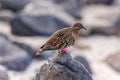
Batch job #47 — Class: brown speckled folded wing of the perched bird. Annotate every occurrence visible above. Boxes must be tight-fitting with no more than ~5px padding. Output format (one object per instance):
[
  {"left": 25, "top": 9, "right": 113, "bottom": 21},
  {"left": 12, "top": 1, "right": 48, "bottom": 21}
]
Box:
[{"left": 41, "top": 28, "right": 75, "bottom": 51}]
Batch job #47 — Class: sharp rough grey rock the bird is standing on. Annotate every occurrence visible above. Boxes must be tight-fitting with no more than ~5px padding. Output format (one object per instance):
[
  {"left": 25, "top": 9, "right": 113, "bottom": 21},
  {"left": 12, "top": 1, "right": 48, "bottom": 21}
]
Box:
[{"left": 36, "top": 53, "right": 93, "bottom": 80}]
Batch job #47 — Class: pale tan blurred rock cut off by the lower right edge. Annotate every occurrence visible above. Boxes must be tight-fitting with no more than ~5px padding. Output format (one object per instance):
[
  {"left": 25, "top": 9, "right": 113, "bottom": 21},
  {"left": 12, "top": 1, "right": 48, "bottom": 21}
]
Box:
[{"left": 104, "top": 52, "right": 120, "bottom": 73}]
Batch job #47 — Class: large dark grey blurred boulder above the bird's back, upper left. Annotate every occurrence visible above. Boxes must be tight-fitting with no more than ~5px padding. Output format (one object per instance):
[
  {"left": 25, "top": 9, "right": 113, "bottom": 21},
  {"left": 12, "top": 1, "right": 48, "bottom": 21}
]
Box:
[{"left": 10, "top": 12, "right": 68, "bottom": 36}]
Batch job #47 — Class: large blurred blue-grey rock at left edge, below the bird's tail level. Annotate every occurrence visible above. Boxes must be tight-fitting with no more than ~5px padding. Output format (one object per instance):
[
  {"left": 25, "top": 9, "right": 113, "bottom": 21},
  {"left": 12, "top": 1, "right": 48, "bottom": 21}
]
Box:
[{"left": 0, "top": 34, "right": 32, "bottom": 71}]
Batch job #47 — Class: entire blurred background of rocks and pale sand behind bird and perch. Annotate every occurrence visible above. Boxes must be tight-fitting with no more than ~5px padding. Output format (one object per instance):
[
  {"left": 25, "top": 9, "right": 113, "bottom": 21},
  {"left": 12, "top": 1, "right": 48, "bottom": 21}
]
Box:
[{"left": 0, "top": 0, "right": 120, "bottom": 80}]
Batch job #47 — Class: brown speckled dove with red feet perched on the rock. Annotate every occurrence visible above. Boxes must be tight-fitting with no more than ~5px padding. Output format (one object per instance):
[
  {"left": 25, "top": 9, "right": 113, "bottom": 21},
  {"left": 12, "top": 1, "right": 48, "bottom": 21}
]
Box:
[{"left": 36, "top": 22, "right": 87, "bottom": 55}]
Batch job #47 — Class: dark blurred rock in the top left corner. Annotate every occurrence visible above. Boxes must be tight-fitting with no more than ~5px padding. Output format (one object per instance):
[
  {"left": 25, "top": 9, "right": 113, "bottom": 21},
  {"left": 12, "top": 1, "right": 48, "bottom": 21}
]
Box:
[{"left": 0, "top": 0, "right": 30, "bottom": 11}]
